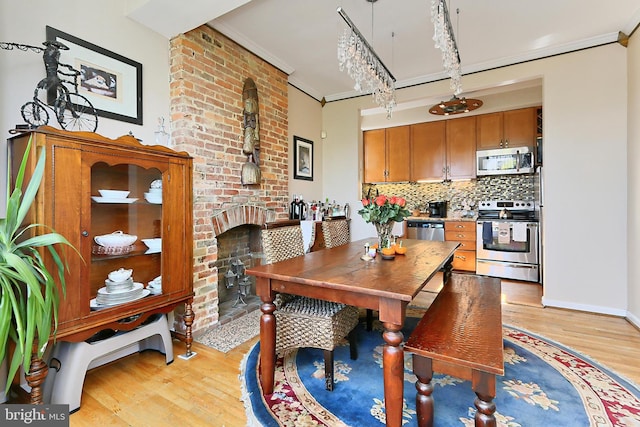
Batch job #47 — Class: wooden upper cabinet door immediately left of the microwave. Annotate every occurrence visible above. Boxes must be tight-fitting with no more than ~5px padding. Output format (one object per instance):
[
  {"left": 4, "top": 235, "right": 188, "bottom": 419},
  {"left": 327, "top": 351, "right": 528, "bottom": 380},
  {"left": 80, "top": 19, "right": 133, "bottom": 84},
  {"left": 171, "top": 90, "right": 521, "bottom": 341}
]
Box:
[{"left": 446, "top": 116, "right": 476, "bottom": 179}]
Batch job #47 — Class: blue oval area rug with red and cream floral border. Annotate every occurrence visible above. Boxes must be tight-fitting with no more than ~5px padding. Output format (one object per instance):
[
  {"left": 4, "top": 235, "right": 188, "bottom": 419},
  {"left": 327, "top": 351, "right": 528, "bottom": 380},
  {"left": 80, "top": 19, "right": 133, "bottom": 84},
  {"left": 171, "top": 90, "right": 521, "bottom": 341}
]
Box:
[{"left": 241, "top": 318, "right": 640, "bottom": 427}]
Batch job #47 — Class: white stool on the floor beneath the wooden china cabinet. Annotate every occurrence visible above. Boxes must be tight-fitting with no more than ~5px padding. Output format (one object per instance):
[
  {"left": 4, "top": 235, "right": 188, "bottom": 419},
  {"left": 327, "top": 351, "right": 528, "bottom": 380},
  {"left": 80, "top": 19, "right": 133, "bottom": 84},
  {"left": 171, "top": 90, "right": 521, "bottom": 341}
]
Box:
[{"left": 43, "top": 315, "right": 173, "bottom": 412}]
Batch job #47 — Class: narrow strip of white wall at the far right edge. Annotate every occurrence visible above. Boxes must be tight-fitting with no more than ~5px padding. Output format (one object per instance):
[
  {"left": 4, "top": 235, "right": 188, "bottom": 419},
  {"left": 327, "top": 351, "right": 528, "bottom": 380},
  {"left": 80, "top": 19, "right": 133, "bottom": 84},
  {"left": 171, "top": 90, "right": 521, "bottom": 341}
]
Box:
[{"left": 627, "top": 32, "right": 640, "bottom": 327}]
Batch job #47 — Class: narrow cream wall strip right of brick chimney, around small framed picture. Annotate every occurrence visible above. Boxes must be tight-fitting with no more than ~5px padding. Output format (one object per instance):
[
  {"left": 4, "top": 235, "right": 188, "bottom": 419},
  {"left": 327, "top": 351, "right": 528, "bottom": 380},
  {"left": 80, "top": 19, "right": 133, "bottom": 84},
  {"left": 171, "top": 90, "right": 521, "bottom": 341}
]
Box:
[{"left": 289, "top": 85, "right": 324, "bottom": 202}]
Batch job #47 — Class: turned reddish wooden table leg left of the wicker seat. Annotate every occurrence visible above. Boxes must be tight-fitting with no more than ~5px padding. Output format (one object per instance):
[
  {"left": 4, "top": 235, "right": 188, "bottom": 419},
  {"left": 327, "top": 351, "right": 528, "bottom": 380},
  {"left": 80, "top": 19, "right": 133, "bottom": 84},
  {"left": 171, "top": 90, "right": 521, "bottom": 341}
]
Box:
[{"left": 260, "top": 299, "right": 276, "bottom": 395}]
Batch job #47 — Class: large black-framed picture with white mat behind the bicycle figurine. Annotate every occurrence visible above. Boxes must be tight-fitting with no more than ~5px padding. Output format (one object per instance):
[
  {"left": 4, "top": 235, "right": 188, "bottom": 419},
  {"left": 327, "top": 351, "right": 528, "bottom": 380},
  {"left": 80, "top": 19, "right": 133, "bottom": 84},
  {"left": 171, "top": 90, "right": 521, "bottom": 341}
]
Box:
[{"left": 47, "top": 26, "right": 142, "bottom": 125}]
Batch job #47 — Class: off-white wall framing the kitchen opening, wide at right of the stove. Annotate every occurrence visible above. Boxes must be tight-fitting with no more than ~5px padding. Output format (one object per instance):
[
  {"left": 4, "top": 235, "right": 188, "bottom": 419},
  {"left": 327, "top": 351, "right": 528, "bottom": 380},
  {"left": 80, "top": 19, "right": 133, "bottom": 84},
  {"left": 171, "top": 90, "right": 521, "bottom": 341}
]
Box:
[{"left": 323, "top": 44, "right": 627, "bottom": 315}]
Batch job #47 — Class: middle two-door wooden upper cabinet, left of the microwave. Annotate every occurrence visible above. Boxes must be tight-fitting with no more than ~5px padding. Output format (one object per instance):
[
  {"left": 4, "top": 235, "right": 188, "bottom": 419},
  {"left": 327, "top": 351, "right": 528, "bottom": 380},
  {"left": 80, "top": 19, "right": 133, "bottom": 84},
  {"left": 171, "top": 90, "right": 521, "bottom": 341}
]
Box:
[{"left": 411, "top": 117, "right": 476, "bottom": 181}]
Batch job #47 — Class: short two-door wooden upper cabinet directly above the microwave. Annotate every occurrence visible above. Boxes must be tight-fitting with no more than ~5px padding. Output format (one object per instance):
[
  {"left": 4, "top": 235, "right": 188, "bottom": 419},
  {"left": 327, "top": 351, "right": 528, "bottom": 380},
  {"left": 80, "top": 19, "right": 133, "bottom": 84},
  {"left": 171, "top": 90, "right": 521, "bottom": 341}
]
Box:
[{"left": 477, "top": 107, "right": 538, "bottom": 150}]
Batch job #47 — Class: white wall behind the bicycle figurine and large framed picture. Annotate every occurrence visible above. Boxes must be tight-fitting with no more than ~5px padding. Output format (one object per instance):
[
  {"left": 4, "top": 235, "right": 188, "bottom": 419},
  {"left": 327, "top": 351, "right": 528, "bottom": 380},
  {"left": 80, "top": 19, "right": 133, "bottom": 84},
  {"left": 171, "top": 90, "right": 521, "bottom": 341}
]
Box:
[{"left": 0, "top": 0, "right": 169, "bottom": 213}]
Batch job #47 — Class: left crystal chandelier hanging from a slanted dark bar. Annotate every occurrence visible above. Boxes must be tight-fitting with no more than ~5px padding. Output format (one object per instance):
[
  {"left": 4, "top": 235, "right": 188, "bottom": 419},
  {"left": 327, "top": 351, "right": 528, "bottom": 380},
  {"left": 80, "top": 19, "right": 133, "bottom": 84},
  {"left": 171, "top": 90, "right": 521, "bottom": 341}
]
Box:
[{"left": 338, "top": 0, "right": 396, "bottom": 118}]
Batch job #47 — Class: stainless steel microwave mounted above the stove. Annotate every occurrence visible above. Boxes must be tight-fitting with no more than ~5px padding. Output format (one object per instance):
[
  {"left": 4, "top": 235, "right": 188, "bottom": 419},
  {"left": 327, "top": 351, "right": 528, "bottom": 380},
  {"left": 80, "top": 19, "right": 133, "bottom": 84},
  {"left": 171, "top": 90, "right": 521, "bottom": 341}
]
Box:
[{"left": 476, "top": 147, "right": 535, "bottom": 176}]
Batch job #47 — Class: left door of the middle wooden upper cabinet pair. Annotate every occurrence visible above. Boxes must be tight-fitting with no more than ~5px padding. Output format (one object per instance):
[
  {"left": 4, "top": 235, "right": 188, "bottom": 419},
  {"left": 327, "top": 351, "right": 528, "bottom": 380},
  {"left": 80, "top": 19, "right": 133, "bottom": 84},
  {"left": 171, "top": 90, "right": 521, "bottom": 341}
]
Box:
[{"left": 411, "top": 120, "right": 446, "bottom": 181}]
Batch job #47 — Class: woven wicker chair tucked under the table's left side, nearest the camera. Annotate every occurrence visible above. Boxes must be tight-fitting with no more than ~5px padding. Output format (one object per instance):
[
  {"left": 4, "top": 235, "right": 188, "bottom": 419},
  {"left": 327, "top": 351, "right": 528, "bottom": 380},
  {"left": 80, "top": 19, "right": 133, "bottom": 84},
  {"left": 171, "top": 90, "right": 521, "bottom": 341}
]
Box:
[{"left": 262, "top": 220, "right": 359, "bottom": 391}]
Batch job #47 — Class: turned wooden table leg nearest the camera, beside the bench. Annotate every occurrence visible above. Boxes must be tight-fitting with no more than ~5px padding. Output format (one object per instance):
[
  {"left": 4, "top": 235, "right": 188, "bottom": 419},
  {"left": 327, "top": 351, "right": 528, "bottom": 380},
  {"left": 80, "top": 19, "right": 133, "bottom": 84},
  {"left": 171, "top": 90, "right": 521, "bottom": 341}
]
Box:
[{"left": 382, "top": 322, "right": 404, "bottom": 427}]
